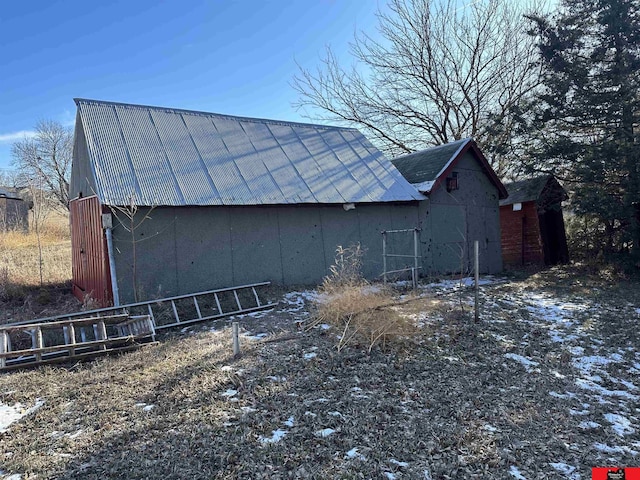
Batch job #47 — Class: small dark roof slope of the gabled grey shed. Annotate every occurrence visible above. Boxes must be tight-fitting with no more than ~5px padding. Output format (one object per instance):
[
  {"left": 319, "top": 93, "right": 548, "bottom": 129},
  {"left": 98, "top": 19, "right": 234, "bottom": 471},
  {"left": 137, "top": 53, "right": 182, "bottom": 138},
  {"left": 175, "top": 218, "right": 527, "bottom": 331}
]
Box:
[{"left": 392, "top": 138, "right": 472, "bottom": 189}]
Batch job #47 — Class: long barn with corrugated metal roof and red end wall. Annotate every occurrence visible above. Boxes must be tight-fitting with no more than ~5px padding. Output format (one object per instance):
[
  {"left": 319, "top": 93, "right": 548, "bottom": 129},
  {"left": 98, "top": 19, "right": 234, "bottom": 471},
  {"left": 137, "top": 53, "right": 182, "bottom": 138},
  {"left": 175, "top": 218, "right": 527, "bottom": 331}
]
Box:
[{"left": 70, "top": 99, "right": 424, "bottom": 304}]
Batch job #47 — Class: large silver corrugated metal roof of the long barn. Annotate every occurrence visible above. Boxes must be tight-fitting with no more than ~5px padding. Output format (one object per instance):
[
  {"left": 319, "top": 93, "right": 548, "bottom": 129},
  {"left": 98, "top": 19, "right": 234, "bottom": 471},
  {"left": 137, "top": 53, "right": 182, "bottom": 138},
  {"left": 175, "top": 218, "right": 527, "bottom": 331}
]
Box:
[{"left": 76, "top": 99, "right": 424, "bottom": 206}]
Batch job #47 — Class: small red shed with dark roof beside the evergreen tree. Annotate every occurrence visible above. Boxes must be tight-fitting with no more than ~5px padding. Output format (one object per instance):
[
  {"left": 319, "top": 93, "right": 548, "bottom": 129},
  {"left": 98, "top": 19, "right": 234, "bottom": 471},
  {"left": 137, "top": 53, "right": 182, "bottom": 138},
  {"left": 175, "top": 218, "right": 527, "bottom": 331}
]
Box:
[{"left": 500, "top": 175, "right": 569, "bottom": 266}]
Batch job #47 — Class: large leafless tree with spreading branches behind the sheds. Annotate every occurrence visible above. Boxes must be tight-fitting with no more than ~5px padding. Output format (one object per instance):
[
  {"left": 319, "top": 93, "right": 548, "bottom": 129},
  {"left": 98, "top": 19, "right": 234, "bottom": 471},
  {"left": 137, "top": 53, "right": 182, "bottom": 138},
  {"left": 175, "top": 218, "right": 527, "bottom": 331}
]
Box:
[{"left": 292, "top": 0, "right": 541, "bottom": 174}]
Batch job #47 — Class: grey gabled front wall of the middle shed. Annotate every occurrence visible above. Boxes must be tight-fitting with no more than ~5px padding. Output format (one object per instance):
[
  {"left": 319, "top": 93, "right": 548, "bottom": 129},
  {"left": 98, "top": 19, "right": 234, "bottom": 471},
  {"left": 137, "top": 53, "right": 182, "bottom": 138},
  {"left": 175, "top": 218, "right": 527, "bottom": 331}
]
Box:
[{"left": 420, "top": 153, "right": 502, "bottom": 275}]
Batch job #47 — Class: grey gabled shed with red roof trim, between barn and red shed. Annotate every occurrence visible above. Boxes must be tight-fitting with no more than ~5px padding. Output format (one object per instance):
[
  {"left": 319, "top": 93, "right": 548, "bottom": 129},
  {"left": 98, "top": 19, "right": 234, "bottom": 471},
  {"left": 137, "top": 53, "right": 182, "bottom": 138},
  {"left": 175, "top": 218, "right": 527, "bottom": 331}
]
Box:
[{"left": 392, "top": 138, "right": 507, "bottom": 274}]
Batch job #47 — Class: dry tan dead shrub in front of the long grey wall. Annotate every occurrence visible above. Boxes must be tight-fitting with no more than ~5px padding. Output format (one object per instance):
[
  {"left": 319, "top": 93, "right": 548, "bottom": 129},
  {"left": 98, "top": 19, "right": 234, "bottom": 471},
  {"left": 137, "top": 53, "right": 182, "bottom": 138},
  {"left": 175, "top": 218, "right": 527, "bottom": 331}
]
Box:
[{"left": 309, "top": 244, "right": 418, "bottom": 352}]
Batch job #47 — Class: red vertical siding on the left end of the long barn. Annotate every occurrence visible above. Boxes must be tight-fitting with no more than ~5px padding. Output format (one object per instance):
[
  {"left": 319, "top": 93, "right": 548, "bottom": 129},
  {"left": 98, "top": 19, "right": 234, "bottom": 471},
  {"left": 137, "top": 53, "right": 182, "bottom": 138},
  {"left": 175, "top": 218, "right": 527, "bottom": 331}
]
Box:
[{"left": 69, "top": 196, "right": 113, "bottom": 307}]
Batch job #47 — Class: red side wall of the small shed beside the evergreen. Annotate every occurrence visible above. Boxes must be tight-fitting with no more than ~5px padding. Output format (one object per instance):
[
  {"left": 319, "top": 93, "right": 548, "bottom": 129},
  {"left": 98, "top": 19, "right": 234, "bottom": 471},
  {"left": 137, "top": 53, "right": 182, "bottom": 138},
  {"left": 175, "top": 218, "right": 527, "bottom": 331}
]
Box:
[{"left": 500, "top": 202, "right": 544, "bottom": 266}]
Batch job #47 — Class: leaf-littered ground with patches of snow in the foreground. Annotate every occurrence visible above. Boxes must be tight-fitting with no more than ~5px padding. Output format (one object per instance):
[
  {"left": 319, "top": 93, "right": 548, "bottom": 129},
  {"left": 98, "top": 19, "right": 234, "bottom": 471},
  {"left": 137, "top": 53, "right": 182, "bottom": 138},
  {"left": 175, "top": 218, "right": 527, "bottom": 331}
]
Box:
[{"left": 0, "top": 267, "right": 640, "bottom": 480}]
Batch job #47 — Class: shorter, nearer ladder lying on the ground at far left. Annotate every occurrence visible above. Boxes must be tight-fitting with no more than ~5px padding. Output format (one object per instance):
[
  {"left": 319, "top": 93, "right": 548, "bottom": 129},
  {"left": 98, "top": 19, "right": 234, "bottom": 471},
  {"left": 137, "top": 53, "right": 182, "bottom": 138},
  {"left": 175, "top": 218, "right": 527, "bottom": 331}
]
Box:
[{"left": 0, "top": 315, "right": 156, "bottom": 370}]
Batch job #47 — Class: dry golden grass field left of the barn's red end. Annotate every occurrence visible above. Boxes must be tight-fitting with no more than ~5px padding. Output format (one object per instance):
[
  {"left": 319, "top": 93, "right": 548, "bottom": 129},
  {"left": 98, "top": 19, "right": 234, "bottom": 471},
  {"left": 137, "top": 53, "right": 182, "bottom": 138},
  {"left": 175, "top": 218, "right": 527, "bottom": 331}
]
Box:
[{"left": 0, "top": 213, "right": 79, "bottom": 323}]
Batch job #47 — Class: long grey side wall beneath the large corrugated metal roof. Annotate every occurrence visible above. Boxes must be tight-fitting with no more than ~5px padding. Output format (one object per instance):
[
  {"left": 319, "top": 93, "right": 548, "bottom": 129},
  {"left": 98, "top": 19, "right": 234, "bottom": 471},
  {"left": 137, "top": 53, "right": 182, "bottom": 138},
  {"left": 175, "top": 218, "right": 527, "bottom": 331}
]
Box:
[{"left": 113, "top": 202, "right": 419, "bottom": 302}]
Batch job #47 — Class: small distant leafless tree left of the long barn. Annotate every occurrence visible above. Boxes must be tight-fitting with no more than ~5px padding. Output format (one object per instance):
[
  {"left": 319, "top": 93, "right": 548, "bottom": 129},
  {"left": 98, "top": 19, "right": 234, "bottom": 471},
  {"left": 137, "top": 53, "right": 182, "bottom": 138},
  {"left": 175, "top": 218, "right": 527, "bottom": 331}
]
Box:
[{"left": 11, "top": 120, "right": 73, "bottom": 209}]
